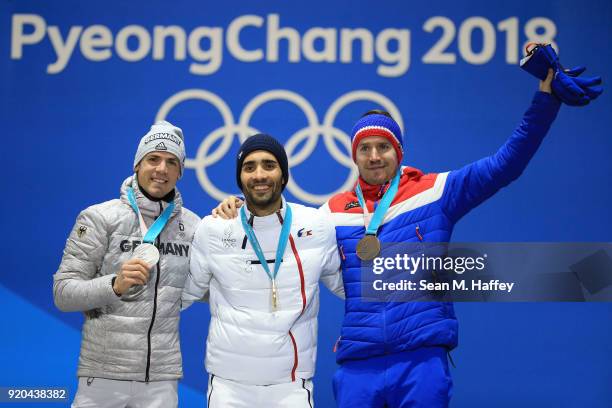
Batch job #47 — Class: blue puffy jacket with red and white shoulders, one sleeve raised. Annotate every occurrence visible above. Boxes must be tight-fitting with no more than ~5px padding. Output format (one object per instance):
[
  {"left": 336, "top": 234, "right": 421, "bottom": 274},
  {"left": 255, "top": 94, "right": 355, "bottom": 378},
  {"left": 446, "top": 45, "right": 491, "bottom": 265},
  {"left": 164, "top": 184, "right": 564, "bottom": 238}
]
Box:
[{"left": 323, "top": 92, "right": 560, "bottom": 364}]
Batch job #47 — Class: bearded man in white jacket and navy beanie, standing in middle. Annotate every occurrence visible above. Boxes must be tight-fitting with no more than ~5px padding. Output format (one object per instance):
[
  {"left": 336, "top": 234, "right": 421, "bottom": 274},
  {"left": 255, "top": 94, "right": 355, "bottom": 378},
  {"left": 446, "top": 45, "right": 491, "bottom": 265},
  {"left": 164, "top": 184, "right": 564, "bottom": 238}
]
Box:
[{"left": 183, "top": 134, "right": 344, "bottom": 408}]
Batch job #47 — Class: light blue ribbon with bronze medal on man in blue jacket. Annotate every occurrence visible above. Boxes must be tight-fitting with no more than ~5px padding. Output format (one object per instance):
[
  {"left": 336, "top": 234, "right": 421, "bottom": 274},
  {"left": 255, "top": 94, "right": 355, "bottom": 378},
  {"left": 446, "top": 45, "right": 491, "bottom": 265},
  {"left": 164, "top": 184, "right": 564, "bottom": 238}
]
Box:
[{"left": 355, "top": 169, "right": 401, "bottom": 261}]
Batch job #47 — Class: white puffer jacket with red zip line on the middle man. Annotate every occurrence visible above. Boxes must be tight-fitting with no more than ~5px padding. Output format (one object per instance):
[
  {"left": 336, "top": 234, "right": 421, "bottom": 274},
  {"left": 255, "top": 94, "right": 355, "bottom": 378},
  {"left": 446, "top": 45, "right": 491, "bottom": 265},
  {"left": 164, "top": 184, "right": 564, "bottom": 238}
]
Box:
[{"left": 183, "top": 200, "right": 344, "bottom": 385}]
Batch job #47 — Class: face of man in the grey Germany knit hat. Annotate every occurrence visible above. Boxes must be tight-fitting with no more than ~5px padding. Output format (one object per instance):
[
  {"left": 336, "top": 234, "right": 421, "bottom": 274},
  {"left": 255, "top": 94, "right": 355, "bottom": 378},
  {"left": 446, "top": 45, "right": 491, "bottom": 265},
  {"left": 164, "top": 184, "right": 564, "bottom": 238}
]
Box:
[{"left": 136, "top": 152, "right": 181, "bottom": 198}]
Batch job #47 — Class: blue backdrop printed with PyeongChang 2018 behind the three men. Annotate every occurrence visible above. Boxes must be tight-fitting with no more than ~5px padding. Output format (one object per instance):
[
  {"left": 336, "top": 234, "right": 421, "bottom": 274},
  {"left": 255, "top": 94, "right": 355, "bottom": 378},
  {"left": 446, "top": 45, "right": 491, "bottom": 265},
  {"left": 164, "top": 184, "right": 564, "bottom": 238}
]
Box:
[{"left": 0, "top": 0, "right": 612, "bottom": 407}]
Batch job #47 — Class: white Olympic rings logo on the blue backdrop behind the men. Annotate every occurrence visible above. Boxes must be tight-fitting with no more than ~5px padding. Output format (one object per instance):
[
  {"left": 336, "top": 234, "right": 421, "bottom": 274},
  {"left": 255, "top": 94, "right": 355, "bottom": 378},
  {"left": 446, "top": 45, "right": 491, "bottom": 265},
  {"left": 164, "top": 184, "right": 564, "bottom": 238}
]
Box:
[{"left": 155, "top": 89, "right": 404, "bottom": 205}]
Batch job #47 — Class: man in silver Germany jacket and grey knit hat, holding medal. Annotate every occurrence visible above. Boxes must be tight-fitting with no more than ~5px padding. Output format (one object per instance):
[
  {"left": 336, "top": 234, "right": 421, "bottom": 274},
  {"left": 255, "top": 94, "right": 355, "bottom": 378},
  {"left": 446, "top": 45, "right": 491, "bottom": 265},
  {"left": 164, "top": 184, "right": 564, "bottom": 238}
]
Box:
[{"left": 53, "top": 121, "right": 199, "bottom": 408}]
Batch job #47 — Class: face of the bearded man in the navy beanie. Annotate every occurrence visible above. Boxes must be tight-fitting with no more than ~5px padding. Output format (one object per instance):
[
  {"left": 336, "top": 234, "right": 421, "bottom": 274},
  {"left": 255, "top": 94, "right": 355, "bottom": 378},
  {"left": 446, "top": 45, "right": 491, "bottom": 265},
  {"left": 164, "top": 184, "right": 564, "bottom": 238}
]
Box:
[{"left": 240, "top": 150, "right": 283, "bottom": 214}]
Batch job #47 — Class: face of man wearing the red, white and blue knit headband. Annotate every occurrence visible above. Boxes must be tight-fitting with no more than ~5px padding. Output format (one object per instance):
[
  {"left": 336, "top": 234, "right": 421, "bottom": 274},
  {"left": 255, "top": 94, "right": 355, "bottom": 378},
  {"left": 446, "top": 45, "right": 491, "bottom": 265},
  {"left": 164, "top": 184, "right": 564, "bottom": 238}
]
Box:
[{"left": 355, "top": 136, "right": 398, "bottom": 185}]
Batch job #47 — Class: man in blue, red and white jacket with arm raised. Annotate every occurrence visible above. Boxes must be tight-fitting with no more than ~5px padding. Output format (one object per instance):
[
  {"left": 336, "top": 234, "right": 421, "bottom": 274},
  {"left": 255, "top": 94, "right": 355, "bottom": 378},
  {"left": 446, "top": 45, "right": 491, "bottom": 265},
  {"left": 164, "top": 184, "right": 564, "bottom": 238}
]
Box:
[{"left": 324, "top": 69, "right": 560, "bottom": 408}]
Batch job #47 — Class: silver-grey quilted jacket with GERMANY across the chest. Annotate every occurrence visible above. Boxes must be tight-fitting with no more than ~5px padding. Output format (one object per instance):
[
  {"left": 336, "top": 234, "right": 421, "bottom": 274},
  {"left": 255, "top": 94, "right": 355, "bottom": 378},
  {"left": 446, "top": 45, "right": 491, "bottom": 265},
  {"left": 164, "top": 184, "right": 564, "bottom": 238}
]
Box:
[{"left": 53, "top": 176, "right": 200, "bottom": 381}]
